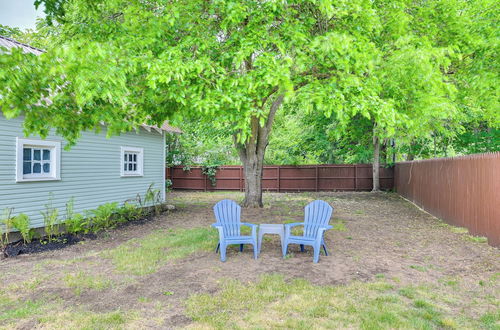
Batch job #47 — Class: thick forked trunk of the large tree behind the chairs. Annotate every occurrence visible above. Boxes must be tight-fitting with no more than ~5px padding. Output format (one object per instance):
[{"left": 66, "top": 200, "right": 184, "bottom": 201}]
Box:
[{"left": 234, "top": 95, "right": 283, "bottom": 207}]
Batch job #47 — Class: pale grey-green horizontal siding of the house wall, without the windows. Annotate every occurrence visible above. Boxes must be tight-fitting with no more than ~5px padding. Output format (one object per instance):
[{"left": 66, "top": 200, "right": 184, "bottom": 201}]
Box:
[{"left": 0, "top": 113, "right": 165, "bottom": 227}]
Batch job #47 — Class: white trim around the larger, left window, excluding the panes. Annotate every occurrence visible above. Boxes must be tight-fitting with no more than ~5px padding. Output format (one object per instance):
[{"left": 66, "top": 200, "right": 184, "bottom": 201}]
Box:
[{"left": 16, "top": 137, "right": 61, "bottom": 182}]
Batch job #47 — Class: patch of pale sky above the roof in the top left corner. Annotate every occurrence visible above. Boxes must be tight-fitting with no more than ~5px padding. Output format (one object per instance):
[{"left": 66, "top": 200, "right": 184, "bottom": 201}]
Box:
[{"left": 0, "top": 0, "right": 45, "bottom": 30}]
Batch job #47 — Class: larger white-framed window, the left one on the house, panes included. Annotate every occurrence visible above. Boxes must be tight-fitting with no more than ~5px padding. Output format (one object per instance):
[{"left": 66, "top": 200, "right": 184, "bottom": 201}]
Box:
[{"left": 16, "top": 138, "right": 61, "bottom": 182}]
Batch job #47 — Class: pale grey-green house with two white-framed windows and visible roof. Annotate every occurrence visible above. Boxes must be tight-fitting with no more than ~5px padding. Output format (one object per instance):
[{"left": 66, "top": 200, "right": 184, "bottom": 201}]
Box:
[{"left": 0, "top": 37, "right": 180, "bottom": 228}]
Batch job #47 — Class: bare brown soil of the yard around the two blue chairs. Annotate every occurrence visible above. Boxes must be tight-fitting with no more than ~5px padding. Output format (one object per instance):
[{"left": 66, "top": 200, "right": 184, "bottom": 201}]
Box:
[{"left": 0, "top": 192, "right": 500, "bottom": 328}]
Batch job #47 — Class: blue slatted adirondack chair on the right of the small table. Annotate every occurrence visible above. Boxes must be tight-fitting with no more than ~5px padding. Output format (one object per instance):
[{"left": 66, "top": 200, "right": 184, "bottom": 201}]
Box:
[{"left": 283, "top": 200, "right": 333, "bottom": 263}]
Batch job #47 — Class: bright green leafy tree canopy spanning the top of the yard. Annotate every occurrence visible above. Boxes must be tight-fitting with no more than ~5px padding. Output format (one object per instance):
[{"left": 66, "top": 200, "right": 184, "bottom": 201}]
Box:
[{"left": 0, "top": 0, "right": 500, "bottom": 159}]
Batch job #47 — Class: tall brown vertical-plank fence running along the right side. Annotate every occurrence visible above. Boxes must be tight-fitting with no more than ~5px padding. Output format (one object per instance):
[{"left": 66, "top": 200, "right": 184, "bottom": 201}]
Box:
[{"left": 395, "top": 152, "right": 500, "bottom": 246}]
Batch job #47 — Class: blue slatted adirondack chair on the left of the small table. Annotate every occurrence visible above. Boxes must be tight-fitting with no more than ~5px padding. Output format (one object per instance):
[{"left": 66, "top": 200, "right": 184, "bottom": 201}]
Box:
[{"left": 212, "top": 199, "right": 257, "bottom": 261}]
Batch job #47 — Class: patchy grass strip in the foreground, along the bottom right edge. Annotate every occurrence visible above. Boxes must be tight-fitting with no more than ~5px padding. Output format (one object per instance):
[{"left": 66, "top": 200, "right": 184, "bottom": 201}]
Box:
[{"left": 187, "top": 274, "right": 500, "bottom": 329}]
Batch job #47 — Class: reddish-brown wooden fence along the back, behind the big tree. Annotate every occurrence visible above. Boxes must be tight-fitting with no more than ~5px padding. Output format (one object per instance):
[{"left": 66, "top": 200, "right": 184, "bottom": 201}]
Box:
[{"left": 166, "top": 164, "right": 394, "bottom": 192}]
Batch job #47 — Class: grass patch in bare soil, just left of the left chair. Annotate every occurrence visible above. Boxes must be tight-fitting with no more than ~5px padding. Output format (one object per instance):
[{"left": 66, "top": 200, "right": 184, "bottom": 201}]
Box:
[{"left": 103, "top": 228, "right": 218, "bottom": 275}]
